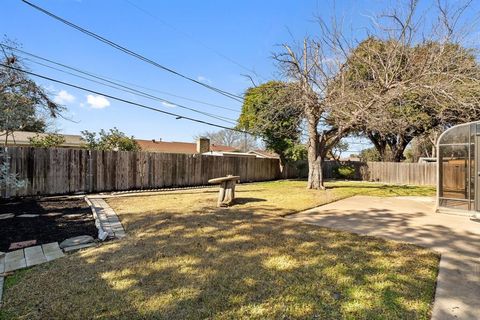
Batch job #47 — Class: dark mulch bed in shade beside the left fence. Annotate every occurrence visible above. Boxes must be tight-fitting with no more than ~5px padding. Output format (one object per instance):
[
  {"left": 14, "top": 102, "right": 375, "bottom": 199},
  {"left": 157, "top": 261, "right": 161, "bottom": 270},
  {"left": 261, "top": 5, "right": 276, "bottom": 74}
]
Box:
[{"left": 0, "top": 198, "right": 97, "bottom": 251}]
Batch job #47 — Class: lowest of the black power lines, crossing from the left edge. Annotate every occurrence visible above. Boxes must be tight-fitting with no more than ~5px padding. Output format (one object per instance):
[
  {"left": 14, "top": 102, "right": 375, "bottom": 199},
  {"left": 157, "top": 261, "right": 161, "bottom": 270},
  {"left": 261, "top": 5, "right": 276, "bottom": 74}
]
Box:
[{"left": 0, "top": 63, "right": 254, "bottom": 136}]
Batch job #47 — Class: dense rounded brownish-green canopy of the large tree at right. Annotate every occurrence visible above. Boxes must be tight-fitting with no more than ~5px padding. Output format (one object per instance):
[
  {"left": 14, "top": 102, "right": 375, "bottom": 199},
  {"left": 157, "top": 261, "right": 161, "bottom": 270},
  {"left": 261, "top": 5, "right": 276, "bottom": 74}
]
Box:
[{"left": 332, "top": 37, "right": 480, "bottom": 161}]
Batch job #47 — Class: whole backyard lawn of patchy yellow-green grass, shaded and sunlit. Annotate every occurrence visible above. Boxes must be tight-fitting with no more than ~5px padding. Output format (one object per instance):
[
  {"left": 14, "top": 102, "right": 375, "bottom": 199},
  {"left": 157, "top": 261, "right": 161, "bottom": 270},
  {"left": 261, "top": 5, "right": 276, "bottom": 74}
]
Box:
[{"left": 0, "top": 181, "right": 439, "bottom": 319}]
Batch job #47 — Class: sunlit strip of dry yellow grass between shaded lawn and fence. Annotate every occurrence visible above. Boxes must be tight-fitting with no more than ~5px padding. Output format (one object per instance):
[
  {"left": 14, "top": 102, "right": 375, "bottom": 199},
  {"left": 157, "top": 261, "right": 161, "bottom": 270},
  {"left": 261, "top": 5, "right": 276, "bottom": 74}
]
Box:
[{"left": 112, "top": 180, "right": 435, "bottom": 220}]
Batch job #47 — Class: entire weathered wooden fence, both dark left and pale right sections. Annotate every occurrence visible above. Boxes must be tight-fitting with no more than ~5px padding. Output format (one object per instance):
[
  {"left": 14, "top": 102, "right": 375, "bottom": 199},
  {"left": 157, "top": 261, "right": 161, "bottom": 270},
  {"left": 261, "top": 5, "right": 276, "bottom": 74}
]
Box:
[{"left": 0, "top": 147, "right": 437, "bottom": 197}]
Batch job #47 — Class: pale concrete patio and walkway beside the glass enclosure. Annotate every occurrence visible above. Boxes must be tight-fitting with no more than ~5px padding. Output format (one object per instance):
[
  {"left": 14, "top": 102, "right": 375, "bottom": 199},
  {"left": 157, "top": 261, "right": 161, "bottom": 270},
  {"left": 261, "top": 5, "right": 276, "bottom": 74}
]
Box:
[{"left": 287, "top": 196, "right": 480, "bottom": 320}]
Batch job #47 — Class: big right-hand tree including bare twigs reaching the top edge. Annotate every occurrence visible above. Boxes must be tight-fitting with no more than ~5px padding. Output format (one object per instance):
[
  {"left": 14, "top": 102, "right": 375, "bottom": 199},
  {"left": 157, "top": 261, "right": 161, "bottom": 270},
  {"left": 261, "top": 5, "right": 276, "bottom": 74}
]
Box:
[{"left": 332, "top": 0, "right": 480, "bottom": 161}]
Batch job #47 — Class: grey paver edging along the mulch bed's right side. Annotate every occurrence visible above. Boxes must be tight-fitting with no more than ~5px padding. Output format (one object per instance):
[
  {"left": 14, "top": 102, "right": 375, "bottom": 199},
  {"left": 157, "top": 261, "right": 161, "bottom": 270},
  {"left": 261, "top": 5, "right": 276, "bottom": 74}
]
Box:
[{"left": 85, "top": 197, "right": 126, "bottom": 239}]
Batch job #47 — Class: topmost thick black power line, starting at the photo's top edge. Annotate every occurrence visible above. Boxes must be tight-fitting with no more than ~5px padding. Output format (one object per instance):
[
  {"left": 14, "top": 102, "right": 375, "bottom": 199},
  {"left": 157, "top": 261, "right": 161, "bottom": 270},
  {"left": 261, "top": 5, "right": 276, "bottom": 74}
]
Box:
[{"left": 22, "top": 0, "right": 243, "bottom": 102}]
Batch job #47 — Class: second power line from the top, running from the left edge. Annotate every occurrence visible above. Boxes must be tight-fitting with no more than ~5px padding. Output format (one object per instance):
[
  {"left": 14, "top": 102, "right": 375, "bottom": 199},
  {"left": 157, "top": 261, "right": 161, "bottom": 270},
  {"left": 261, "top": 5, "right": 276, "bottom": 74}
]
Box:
[{"left": 0, "top": 42, "right": 240, "bottom": 113}]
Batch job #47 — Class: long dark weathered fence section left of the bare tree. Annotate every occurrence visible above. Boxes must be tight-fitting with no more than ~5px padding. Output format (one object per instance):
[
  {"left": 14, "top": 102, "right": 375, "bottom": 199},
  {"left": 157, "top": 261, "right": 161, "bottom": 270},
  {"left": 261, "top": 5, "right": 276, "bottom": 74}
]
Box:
[{"left": 2, "top": 147, "right": 280, "bottom": 196}]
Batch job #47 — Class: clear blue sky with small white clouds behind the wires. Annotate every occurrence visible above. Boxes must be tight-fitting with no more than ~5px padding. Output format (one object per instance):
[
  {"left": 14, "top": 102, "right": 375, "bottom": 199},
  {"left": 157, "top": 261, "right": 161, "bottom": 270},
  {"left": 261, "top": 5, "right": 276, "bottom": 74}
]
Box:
[{"left": 0, "top": 0, "right": 478, "bottom": 150}]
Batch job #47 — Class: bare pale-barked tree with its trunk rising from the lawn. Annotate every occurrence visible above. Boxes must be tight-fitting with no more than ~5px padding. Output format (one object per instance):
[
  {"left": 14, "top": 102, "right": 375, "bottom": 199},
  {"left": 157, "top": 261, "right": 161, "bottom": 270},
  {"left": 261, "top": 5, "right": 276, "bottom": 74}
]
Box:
[{"left": 273, "top": 19, "right": 357, "bottom": 189}]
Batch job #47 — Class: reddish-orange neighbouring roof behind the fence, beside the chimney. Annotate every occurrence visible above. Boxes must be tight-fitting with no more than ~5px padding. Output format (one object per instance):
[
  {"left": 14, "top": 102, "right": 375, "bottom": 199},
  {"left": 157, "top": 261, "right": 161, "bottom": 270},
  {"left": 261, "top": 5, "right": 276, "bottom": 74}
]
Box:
[{"left": 136, "top": 140, "right": 236, "bottom": 154}]
